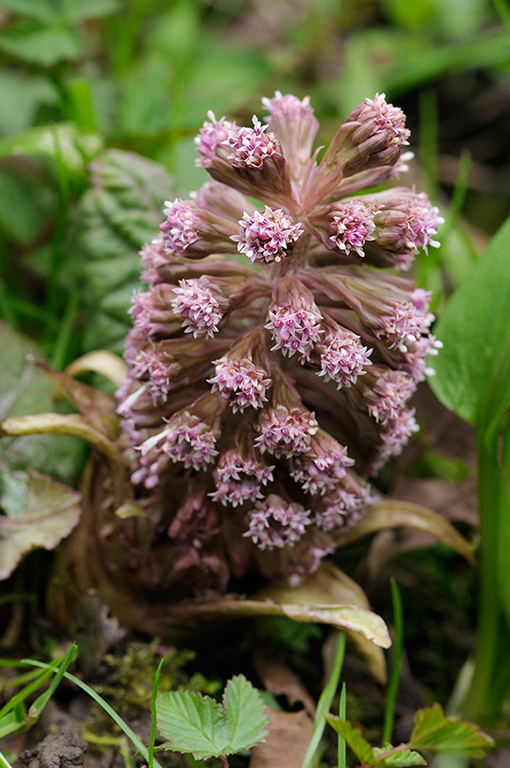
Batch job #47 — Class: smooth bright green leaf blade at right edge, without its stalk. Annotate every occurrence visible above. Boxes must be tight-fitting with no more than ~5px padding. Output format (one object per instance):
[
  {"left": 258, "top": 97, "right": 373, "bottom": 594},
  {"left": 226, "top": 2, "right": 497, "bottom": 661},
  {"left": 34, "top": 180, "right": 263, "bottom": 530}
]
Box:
[{"left": 430, "top": 214, "right": 510, "bottom": 424}]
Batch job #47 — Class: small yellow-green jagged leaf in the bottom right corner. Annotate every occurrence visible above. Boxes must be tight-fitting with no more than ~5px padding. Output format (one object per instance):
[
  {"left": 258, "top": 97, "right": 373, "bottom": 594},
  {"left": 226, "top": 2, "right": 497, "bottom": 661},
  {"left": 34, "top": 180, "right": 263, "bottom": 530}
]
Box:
[{"left": 409, "top": 704, "right": 494, "bottom": 758}]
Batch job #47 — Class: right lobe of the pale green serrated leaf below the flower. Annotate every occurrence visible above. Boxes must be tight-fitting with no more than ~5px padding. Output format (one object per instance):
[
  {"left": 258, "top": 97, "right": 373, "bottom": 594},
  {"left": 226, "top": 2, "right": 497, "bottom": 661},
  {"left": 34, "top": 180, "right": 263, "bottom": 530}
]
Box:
[{"left": 223, "top": 675, "right": 267, "bottom": 755}]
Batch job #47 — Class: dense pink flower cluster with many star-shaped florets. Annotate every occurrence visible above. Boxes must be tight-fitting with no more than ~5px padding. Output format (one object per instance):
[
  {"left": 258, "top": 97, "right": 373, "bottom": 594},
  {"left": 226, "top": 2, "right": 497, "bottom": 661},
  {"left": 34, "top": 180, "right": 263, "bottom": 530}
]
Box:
[{"left": 118, "top": 92, "right": 443, "bottom": 592}]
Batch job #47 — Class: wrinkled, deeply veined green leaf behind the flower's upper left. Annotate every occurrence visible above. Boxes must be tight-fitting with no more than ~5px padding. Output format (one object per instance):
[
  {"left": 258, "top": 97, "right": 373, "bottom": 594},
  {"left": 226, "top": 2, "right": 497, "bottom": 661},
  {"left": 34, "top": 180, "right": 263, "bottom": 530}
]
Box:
[{"left": 68, "top": 149, "right": 173, "bottom": 352}]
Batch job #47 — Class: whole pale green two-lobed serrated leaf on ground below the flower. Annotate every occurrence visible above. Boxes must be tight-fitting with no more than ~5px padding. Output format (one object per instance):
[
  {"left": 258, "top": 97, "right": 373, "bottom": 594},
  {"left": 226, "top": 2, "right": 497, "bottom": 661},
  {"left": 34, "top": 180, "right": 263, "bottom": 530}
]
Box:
[{"left": 156, "top": 675, "right": 267, "bottom": 760}]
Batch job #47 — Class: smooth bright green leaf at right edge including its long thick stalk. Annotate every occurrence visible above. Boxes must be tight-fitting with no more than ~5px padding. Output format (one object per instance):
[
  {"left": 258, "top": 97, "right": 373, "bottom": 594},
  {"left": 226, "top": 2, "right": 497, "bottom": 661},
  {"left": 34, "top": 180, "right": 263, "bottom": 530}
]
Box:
[{"left": 431, "top": 214, "right": 510, "bottom": 718}]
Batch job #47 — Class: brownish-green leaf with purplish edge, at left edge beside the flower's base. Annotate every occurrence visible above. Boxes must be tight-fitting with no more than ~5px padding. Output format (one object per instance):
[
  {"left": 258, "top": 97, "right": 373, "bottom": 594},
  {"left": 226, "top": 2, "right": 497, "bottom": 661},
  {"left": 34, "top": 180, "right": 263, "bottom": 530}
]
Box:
[{"left": 0, "top": 470, "right": 81, "bottom": 580}]
